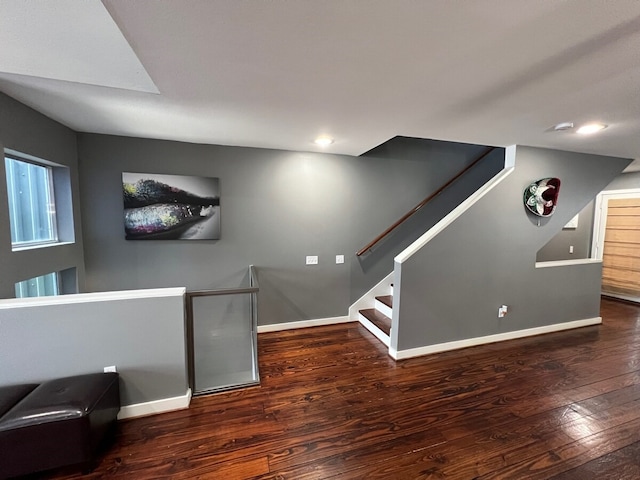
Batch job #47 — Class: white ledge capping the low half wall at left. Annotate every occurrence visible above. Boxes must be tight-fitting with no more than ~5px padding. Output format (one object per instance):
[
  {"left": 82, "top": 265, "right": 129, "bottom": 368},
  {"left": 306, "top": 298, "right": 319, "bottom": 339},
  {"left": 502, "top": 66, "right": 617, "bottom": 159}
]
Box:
[{"left": 0, "top": 287, "right": 187, "bottom": 310}]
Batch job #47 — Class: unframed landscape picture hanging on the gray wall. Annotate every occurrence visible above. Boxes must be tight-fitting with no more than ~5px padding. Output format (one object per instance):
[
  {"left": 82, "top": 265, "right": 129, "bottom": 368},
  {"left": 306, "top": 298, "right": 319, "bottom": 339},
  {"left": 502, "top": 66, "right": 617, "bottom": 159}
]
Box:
[{"left": 122, "top": 172, "right": 220, "bottom": 240}]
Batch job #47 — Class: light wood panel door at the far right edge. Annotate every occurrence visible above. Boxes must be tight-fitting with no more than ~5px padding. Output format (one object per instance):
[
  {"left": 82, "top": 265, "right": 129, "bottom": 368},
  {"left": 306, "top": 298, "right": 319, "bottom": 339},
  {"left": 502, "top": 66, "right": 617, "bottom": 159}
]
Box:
[{"left": 602, "top": 198, "right": 640, "bottom": 298}]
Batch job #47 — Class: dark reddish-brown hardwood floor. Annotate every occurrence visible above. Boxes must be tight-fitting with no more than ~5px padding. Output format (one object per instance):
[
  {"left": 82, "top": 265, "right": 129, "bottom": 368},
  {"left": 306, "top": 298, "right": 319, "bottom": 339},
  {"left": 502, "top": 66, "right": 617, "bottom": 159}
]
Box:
[{"left": 44, "top": 299, "right": 640, "bottom": 480}]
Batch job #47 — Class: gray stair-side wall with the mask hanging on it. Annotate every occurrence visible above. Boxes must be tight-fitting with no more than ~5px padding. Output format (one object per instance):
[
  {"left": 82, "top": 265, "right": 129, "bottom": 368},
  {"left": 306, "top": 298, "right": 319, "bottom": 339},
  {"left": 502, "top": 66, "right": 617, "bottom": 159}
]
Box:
[{"left": 392, "top": 147, "right": 630, "bottom": 350}]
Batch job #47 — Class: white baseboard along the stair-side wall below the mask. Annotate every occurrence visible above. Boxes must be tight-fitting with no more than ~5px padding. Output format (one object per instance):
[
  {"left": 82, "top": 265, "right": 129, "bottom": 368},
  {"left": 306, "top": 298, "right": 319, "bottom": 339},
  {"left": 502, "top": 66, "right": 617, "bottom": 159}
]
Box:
[{"left": 389, "top": 317, "right": 602, "bottom": 360}]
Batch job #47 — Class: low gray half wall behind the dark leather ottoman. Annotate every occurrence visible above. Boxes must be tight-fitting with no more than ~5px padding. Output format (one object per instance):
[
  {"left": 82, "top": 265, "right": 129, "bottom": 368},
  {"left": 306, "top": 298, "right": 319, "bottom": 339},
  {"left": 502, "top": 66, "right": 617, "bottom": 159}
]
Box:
[{"left": 0, "top": 293, "right": 188, "bottom": 406}]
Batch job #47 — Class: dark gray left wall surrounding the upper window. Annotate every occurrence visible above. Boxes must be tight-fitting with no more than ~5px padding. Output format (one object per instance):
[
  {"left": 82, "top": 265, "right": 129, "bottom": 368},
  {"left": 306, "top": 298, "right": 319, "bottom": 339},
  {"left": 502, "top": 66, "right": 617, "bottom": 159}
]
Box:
[{"left": 0, "top": 93, "right": 84, "bottom": 298}]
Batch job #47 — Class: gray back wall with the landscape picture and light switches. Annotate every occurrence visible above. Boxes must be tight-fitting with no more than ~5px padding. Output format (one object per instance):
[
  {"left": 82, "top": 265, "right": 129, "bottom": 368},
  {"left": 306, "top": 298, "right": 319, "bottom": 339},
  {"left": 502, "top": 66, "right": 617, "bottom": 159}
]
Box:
[{"left": 78, "top": 134, "right": 496, "bottom": 325}]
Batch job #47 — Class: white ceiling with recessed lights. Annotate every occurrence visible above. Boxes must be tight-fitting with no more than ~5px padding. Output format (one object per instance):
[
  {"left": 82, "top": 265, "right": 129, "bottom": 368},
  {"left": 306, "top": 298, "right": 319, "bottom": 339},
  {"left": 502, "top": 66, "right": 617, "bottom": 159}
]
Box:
[{"left": 0, "top": 0, "right": 640, "bottom": 158}]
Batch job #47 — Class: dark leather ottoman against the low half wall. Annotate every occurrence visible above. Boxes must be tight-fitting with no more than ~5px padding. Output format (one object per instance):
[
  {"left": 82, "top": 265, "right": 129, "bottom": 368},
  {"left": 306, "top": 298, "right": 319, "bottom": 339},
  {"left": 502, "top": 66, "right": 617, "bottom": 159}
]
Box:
[{"left": 0, "top": 373, "right": 120, "bottom": 478}]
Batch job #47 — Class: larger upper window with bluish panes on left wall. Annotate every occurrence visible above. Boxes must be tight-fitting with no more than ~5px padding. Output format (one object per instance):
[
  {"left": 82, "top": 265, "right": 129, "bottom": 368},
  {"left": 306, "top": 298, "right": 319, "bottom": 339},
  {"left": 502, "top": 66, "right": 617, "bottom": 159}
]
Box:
[{"left": 4, "top": 157, "right": 58, "bottom": 248}]
